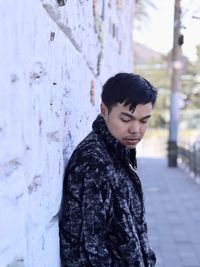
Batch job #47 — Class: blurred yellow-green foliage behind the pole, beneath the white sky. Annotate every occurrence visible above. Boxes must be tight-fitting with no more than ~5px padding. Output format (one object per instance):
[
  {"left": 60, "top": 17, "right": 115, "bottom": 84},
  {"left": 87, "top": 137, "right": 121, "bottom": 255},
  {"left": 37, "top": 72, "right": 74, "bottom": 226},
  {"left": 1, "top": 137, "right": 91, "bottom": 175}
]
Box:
[{"left": 134, "top": 44, "right": 200, "bottom": 128}]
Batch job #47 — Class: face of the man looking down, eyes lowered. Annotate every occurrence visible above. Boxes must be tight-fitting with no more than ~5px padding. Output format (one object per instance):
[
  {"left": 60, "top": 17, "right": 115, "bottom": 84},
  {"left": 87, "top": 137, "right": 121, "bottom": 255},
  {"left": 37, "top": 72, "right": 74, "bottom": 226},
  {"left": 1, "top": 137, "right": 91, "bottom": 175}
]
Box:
[{"left": 101, "top": 103, "right": 153, "bottom": 149}]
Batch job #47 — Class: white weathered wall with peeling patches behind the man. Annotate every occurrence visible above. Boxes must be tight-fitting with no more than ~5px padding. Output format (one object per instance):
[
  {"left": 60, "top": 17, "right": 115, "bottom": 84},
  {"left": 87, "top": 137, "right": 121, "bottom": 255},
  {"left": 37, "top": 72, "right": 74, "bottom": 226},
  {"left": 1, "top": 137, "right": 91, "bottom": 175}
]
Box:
[{"left": 0, "top": 0, "right": 133, "bottom": 267}]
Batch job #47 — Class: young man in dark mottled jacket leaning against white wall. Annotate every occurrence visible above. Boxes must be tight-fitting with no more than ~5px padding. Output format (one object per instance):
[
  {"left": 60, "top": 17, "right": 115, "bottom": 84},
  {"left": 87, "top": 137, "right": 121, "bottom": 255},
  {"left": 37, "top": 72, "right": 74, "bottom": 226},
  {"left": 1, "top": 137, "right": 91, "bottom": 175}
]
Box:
[{"left": 60, "top": 73, "right": 157, "bottom": 267}]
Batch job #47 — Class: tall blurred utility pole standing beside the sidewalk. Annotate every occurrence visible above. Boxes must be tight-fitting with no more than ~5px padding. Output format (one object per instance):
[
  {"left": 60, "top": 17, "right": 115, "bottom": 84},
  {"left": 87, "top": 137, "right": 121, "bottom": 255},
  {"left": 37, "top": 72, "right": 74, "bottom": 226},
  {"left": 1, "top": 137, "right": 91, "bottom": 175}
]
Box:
[{"left": 168, "top": 0, "right": 183, "bottom": 167}]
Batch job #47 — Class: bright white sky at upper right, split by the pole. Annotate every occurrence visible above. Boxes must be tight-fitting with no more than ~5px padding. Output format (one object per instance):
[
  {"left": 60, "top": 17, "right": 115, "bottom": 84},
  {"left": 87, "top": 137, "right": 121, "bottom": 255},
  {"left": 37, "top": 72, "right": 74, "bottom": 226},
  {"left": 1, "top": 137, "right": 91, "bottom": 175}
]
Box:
[{"left": 133, "top": 0, "right": 200, "bottom": 61}]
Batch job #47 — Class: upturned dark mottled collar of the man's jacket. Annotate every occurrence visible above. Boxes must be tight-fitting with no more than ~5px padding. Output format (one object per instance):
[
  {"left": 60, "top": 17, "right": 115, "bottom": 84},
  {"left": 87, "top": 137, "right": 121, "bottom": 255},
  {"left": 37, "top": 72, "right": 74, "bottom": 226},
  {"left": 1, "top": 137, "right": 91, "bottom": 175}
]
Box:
[{"left": 92, "top": 114, "right": 137, "bottom": 169}]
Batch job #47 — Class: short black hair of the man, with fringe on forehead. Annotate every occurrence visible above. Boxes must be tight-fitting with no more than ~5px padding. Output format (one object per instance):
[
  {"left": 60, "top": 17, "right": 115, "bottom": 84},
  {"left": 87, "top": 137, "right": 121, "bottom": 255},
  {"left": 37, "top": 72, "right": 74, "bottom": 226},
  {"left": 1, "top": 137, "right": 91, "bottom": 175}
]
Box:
[{"left": 101, "top": 73, "right": 157, "bottom": 111}]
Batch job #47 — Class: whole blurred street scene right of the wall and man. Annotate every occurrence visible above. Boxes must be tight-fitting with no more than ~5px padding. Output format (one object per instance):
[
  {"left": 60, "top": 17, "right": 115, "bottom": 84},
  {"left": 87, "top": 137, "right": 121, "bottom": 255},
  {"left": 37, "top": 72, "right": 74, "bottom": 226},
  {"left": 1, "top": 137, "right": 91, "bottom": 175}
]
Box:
[{"left": 133, "top": 0, "right": 200, "bottom": 267}]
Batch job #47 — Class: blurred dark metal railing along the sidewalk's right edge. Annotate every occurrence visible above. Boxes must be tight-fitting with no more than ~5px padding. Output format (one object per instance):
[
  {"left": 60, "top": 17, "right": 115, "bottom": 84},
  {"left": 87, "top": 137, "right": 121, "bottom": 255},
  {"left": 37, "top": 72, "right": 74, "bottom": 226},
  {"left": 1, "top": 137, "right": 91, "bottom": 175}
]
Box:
[{"left": 178, "top": 142, "right": 200, "bottom": 181}]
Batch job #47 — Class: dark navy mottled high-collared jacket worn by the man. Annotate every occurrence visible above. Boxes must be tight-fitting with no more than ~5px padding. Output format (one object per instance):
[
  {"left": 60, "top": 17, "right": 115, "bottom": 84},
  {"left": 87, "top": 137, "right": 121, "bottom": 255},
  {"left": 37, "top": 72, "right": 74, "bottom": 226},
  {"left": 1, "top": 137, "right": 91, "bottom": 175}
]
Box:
[{"left": 59, "top": 115, "right": 156, "bottom": 267}]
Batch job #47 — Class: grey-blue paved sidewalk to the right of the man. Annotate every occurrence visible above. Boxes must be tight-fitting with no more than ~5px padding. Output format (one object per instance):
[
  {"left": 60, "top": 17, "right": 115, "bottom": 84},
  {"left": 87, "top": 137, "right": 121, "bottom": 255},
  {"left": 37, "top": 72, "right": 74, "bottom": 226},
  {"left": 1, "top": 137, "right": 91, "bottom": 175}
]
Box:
[{"left": 138, "top": 158, "right": 200, "bottom": 267}]
